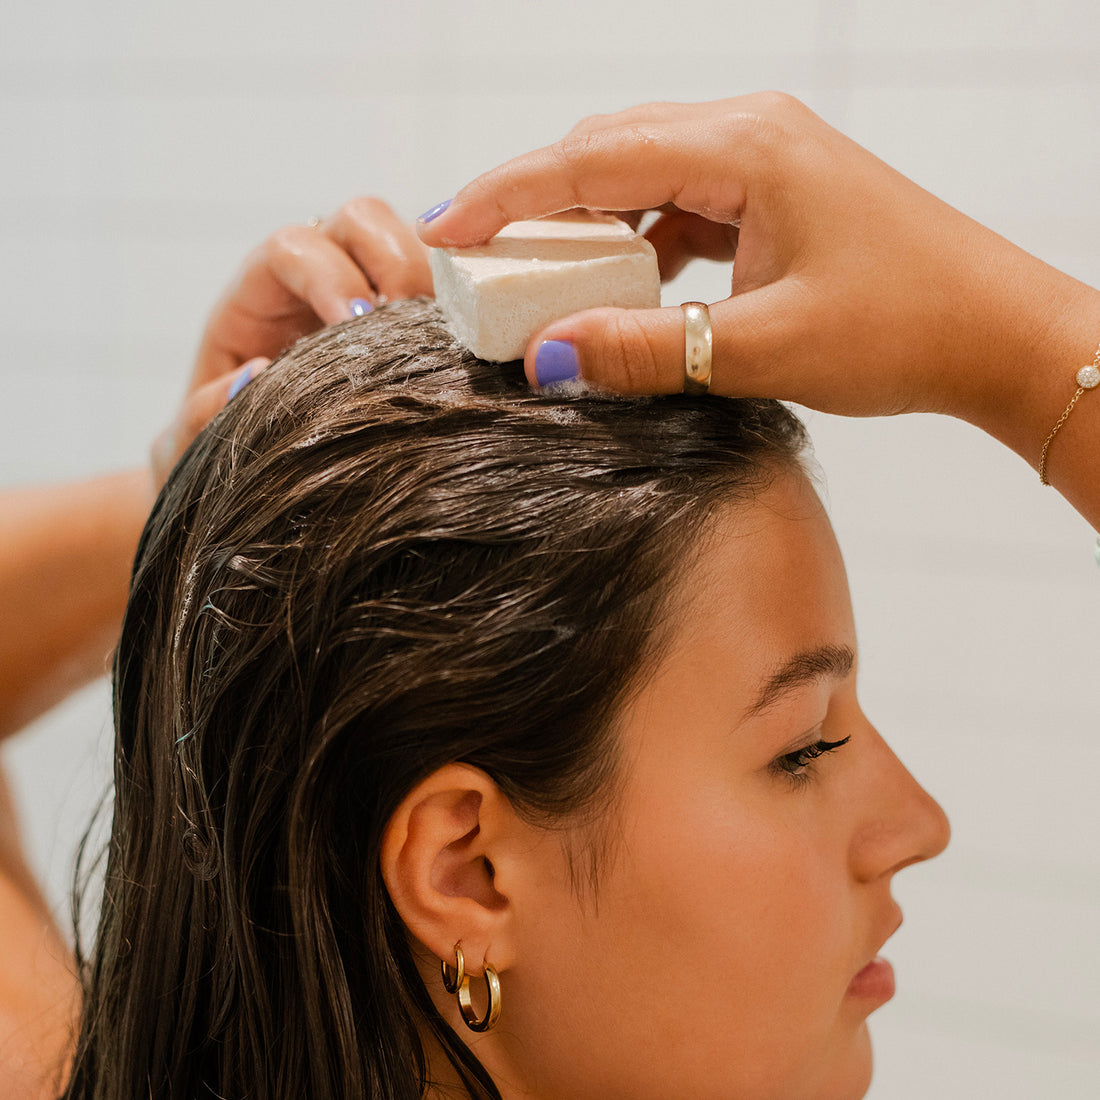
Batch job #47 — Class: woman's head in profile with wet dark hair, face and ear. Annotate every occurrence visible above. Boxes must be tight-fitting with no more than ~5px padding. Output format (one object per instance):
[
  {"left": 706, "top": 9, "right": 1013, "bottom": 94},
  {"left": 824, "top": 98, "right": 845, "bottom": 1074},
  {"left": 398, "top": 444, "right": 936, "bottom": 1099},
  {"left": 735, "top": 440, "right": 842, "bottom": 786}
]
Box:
[{"left": 72, "top": 303, "right": 943, "bottom": 1097}]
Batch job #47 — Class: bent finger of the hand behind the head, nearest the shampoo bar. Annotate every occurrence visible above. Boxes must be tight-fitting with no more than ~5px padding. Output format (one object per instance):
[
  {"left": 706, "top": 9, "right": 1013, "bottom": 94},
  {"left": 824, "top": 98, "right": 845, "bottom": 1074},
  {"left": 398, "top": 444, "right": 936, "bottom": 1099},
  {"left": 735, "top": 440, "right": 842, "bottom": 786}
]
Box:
[{"left": 321, "top": 197, "right": 432, "bottom": 300}]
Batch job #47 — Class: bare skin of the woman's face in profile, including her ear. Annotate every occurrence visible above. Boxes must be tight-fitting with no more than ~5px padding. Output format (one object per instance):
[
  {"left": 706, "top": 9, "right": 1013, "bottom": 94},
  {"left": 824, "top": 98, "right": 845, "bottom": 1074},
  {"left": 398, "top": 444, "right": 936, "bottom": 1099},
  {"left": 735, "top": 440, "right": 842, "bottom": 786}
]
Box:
[{"left": 382, "top": 473, "right": 948, "bottom": 1100}]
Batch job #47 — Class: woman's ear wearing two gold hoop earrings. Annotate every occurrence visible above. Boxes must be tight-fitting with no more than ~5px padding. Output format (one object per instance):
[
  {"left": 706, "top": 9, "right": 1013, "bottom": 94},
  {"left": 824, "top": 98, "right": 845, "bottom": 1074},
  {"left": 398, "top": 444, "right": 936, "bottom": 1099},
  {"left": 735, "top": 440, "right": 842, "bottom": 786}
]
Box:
[{"left": 380, "top": 763, "right": 525, "bottom": 974}]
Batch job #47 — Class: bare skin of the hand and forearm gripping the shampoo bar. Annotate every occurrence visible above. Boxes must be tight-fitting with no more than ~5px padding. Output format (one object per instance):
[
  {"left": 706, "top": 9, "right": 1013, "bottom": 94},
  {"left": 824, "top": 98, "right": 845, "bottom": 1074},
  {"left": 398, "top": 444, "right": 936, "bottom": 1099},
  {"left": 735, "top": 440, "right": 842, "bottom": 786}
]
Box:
[{"left": 420, "top": 92, "right": 1100, "bottom": 528}]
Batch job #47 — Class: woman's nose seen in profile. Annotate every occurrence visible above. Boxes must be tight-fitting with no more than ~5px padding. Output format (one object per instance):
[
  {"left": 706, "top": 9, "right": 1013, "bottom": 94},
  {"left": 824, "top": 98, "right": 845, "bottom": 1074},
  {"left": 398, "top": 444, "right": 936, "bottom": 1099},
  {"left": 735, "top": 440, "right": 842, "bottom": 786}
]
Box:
[{"left": 850, "top": 726, "right": 952, "bottom": 881}]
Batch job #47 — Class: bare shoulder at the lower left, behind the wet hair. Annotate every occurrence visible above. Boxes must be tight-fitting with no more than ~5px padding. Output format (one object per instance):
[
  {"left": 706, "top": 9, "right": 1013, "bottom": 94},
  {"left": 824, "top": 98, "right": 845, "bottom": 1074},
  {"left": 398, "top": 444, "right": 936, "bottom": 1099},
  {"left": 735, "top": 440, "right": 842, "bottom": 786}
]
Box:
[{"left": 0, "top": 773, "right": 78, "bottom": 1100}]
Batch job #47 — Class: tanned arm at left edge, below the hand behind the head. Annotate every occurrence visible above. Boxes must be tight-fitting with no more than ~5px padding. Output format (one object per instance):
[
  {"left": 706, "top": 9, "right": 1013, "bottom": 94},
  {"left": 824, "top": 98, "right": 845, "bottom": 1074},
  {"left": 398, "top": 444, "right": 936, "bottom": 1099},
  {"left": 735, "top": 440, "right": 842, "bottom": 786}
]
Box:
[{"left": 0, "top": 470, "right": 153, "bottom": 738}]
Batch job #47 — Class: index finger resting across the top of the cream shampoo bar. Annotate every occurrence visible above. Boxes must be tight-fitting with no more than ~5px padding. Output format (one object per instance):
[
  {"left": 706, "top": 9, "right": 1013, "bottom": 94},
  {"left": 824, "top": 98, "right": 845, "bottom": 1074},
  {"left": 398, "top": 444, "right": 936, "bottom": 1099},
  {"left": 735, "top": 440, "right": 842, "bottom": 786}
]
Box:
[{"left": 417, "top": 116, "right": 749, "bottom": 246}]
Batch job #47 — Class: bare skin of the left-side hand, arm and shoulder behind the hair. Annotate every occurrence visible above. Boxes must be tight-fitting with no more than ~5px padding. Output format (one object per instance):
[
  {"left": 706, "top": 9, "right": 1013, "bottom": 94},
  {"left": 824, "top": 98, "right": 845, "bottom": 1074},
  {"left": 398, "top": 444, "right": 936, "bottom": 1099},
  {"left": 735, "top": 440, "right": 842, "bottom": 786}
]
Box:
[{"left": 0, "top": 198, "right": 432, "bottom": 1098}]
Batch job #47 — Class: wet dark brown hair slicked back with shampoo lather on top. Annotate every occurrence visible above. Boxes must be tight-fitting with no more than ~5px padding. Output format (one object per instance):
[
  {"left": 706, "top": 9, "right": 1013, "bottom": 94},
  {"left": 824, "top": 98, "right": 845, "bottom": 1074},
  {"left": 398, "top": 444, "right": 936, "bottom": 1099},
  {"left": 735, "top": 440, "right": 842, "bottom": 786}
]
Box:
[{"left": 66, "top": 301, "right": 803, "bottom": 1100}]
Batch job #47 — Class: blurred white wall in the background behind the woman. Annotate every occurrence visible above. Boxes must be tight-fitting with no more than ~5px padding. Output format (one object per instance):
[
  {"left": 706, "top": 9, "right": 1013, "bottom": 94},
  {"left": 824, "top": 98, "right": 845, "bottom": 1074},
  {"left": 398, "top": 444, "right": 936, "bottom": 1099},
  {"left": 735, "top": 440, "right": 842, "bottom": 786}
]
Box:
[{"left": 0, "top": 0, "right": 1100, "bottom": 1100}]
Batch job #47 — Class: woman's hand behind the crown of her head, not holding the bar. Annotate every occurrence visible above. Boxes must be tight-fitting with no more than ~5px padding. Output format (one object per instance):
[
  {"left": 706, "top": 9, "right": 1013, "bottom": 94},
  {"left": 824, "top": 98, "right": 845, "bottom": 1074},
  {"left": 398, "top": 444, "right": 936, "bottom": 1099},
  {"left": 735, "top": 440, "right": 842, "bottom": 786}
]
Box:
[{"left": 153, "top": 198, "right": 432, "bottom": 486}]
